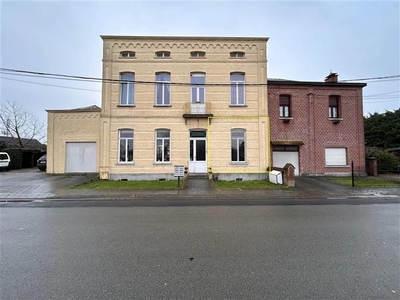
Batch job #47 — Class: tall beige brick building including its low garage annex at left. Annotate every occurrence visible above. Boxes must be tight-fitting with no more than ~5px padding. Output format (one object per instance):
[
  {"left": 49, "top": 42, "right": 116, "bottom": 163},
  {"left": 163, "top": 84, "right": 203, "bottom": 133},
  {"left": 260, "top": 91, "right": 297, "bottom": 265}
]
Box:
[{"left": 47, "top": 36, "right": 271, "bottom": 180}]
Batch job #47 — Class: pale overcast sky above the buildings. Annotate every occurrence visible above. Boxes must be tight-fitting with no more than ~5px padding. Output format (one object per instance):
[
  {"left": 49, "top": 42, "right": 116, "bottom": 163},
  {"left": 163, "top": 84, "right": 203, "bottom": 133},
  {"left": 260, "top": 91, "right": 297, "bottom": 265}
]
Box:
[{"left": 0, "top": 0, "right": 400, "bottom": 126}]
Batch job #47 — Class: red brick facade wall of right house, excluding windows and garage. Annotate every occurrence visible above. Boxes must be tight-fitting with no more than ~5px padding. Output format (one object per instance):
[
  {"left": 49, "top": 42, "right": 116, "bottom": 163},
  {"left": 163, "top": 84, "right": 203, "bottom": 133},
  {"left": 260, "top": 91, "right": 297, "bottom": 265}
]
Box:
[{"left": 268, "top": 81, "right": 365, "bottom": 175}]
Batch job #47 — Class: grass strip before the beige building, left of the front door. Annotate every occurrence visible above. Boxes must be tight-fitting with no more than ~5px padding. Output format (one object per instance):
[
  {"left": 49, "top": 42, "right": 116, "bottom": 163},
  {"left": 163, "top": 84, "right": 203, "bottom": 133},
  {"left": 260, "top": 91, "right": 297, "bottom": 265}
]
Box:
[{"left": 74, "top": 179, "right": 182, "bottom": 190}]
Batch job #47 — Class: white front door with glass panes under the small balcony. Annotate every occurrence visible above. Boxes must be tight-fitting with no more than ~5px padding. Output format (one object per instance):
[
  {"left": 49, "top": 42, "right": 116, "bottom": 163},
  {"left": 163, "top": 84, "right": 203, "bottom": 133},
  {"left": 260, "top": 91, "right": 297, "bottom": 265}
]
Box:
[{"left": 189, "top": 131, "right": 207, "bottom": 173}]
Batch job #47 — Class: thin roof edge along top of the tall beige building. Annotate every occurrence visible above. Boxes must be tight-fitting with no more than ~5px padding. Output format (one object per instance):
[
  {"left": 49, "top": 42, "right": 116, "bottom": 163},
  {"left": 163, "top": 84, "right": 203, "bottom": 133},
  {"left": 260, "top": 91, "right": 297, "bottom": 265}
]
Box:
[{"left": 100, "top": 35, "right": 269, "bottom": 42}]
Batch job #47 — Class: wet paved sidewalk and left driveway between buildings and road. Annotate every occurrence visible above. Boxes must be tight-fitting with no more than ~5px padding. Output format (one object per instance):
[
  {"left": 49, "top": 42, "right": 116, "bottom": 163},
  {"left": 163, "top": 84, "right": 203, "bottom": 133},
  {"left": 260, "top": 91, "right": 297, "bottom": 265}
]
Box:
[{"left": 0, "top": 168, "right": 400, "bottom": 202}]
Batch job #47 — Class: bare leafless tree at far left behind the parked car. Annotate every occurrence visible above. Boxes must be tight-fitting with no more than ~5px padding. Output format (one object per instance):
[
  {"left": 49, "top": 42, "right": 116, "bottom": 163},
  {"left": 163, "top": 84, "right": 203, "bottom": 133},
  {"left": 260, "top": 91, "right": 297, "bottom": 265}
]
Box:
[{"left": 0, "top": 101, "right": 46, "bottom": 148}]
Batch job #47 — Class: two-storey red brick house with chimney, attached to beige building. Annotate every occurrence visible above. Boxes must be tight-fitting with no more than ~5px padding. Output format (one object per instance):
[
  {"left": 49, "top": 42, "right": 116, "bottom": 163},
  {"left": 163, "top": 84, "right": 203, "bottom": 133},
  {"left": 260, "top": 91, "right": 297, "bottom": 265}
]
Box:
[{"left": 268, "top": 73, "right": 366, "bottom": 175}]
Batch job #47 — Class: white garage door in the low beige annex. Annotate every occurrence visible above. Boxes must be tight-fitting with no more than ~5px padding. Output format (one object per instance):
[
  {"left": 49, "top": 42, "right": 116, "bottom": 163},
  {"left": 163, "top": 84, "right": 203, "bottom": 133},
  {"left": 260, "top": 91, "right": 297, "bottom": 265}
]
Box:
[{"left": 65, "top": 143, "right": 97, "bottom": 173}]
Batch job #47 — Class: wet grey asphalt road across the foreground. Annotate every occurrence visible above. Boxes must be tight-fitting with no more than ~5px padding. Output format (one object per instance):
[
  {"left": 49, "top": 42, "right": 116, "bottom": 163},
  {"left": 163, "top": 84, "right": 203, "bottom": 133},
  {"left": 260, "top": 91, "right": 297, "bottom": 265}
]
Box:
[{"left": 0, "top": 202, "right": 400, "bottom": 300}]
